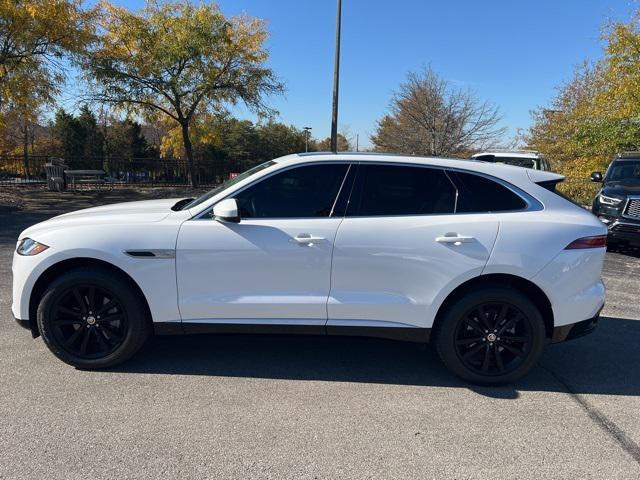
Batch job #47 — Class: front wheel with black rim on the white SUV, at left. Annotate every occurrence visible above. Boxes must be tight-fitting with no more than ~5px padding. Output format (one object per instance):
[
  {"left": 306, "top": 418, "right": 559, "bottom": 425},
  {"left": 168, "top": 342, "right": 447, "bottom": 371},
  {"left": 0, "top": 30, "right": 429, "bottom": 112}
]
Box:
[{"left": 37, "top": 267, "right": 151, "bottom": 370}]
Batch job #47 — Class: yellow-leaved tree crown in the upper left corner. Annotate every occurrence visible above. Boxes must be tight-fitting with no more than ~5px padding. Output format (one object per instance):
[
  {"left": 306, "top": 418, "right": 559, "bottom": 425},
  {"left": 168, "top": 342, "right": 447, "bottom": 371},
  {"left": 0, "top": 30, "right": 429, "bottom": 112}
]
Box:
[{"left": 0, "top": 0, "right": 95, "bottom": 116}]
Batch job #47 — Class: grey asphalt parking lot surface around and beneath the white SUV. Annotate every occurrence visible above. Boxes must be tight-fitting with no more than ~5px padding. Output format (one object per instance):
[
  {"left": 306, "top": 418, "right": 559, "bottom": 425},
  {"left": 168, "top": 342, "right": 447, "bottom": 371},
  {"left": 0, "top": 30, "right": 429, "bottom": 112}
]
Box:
[{"left": 0, "top": 192, "right": 640, "bottom": 479}]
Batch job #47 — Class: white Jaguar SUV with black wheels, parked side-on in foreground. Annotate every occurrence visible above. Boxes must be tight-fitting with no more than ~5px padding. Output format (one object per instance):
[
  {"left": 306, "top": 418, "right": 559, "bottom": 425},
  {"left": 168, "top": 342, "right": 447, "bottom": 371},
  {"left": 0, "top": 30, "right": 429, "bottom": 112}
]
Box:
[{"left": 13, "top": 154, "right": 607, "bottom": 384}]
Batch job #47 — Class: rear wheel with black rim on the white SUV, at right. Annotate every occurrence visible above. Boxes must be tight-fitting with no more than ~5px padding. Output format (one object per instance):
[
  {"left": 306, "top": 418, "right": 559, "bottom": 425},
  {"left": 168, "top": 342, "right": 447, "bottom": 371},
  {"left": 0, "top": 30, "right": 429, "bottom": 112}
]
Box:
[{"left": 435, "top": 285, "right": 546, "bottom": 385}]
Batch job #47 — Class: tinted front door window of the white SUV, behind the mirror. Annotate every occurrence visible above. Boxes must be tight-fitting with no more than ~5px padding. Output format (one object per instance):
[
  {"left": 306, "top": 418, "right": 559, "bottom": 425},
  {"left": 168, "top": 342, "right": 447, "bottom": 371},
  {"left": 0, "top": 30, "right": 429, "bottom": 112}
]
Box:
[{"left": 234, "top": 163, "right": 349, "bottom": 218}]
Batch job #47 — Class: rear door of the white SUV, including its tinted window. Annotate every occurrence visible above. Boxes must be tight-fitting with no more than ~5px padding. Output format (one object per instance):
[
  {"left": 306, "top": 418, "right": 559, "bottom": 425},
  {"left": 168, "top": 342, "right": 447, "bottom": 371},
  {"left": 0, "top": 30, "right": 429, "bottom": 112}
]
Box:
[{"left": 327, "top": 163, "right": 499, "bottom": 328}]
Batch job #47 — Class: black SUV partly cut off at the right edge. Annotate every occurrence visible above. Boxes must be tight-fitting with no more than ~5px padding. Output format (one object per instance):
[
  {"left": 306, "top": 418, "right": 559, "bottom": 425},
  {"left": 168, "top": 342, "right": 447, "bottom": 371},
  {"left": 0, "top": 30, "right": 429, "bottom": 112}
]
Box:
[{"left": 591, "top": 152, "right": 640, "bottom": 246}]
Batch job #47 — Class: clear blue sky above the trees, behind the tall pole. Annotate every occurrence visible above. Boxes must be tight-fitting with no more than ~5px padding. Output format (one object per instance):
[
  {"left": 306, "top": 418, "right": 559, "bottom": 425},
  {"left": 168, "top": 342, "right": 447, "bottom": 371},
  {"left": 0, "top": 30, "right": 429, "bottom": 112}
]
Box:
[{"left": 106, "top": 0, "right": 640, "bottom": 147}]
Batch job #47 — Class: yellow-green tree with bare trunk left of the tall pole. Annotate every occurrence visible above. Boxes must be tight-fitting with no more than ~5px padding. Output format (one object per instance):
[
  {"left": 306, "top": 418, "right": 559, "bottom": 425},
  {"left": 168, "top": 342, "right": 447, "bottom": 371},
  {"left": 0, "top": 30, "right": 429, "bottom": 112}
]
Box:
[{"left": 84, "top": 2, "right": 283, "bottom": 186}]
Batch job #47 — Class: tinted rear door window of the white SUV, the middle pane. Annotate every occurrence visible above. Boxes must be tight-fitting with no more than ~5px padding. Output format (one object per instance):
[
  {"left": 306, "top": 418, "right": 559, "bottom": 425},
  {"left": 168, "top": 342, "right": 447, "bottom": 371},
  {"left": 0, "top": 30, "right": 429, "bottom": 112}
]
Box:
[{"left": 347, "top": 165, "right": 456, "bottom": 217}]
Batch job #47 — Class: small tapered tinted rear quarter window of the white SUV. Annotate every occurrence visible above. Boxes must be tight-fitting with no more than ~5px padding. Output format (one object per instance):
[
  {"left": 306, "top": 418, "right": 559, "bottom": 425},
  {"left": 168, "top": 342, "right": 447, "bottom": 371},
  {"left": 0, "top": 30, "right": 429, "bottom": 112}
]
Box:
[{"left": 448, "top": 171, "right": 527, "bottom": 213}]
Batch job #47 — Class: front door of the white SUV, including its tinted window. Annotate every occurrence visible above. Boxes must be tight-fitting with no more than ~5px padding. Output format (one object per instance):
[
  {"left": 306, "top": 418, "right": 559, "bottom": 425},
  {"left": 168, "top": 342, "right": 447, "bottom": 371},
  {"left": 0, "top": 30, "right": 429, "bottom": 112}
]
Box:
[{"left": 176, "top": 163, "right": 349, "bottom": 326}]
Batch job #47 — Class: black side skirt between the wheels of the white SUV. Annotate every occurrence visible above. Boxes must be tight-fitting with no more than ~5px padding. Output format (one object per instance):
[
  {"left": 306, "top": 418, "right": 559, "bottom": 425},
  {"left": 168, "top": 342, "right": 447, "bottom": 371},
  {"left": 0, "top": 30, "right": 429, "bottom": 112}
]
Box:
[{"left": 153, "top": 322, "right": 431, "bottom": 343}]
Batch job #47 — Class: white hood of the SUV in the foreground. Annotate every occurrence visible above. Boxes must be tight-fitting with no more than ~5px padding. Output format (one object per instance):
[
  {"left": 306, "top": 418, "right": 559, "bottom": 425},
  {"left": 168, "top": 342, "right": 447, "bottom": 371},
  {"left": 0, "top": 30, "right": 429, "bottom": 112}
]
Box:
[{"left": 20, "top": 198, "right": 180, "bottom": 238}]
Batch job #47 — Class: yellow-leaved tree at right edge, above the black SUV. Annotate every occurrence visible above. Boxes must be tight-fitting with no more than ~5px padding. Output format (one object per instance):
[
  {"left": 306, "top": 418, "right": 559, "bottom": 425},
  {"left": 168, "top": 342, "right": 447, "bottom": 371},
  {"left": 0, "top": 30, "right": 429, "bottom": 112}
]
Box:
[{"left": 525, "top": 11, "right": 640, "bottom": 201}]
